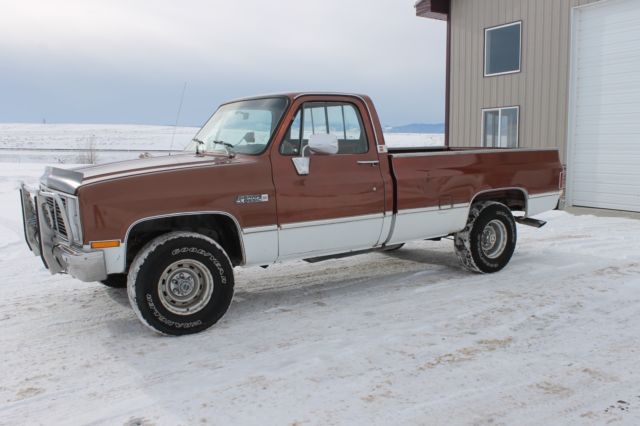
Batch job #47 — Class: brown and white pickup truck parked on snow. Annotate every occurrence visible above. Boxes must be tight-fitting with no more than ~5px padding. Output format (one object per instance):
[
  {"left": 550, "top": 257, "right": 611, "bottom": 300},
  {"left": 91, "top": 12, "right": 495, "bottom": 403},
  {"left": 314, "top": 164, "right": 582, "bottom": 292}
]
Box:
[{"left": 21, "top": 93, "right": 562, "bottom": 335}]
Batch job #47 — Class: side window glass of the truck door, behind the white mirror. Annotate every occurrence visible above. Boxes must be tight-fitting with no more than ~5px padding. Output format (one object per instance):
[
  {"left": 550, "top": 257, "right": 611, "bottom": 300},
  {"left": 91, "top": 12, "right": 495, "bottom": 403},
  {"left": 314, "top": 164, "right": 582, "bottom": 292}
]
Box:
[{"left": 280, "top": 102, "right": 369, "bottom": 155}]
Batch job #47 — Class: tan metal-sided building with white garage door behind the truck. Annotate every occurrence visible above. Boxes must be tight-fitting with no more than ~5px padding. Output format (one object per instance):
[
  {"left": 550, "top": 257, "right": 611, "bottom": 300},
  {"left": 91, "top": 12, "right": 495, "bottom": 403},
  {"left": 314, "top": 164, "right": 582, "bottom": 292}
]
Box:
[{"left": 416, "top": 0, "right": 640, "bottom": 211}]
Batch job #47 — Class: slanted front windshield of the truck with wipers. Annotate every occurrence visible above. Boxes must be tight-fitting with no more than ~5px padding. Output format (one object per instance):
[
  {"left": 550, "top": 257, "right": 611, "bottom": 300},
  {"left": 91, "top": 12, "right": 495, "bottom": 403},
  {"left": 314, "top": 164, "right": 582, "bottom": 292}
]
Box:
[{"left": 185, "top": 98, "right": 287, "bottom": 155}]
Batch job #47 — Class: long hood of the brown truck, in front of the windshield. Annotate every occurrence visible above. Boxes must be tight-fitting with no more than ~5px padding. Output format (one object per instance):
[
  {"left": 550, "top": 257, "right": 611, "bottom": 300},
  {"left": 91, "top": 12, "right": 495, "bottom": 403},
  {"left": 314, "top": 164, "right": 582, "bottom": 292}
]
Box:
[{"left": 40, "top": 153, "right": 236, "bottom": 194}]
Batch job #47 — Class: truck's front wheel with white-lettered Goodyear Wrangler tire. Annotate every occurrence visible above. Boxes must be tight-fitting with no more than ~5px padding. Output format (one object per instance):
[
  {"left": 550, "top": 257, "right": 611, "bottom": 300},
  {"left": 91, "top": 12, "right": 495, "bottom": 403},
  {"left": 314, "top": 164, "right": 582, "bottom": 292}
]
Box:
[{"left": 127, "top": 232, "right": 234, "bottom": 336}]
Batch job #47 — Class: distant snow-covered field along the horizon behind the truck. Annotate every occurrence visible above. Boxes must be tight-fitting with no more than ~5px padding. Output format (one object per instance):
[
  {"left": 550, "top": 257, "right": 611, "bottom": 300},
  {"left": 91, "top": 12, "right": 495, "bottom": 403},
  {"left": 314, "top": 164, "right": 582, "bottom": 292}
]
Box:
[{"left": 0, "top": 124, "right": 444, "bottom": 164}]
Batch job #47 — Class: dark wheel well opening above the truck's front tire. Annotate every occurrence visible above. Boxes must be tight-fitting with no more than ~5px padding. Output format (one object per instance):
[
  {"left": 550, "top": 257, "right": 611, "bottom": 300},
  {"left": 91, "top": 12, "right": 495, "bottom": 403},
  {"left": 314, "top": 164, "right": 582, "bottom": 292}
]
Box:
[{"left": 127, "top": 214, "right": 244, "bottom": 270}]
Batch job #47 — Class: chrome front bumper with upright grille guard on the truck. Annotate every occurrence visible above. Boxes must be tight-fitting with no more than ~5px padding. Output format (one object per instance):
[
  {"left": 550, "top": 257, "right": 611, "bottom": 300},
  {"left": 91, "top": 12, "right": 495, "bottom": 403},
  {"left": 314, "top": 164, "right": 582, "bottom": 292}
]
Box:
[{"left": 20, "top": 184, "right": 107, "bottom": 281}]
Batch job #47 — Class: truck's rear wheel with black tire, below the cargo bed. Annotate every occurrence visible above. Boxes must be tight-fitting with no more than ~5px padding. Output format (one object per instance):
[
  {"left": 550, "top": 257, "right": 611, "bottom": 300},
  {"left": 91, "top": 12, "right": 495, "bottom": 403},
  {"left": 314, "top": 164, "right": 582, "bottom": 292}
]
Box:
[{"left": 454, "top": 201, "right": 517, "bottom": 273}]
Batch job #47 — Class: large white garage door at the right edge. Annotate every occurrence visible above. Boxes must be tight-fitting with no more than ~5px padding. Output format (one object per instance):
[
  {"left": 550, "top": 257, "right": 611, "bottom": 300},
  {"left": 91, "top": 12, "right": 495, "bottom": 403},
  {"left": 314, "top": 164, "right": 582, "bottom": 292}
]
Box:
[{"left": 568, "top": 0, "right": 640, "bottom": 211}]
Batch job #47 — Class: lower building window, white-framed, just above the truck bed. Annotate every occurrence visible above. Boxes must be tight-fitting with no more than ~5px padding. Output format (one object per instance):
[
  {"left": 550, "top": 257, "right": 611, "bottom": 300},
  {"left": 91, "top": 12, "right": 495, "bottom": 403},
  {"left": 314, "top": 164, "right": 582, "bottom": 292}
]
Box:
[{"left": 482, "top": 107, "right": 520, "bottom": 148}]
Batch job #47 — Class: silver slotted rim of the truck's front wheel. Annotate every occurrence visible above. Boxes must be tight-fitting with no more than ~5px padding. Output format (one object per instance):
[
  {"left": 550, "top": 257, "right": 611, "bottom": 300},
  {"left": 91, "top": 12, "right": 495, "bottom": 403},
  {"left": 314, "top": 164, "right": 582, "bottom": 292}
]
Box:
[{"left": 158, "top": 259, "right": 213, "bottom": 315}]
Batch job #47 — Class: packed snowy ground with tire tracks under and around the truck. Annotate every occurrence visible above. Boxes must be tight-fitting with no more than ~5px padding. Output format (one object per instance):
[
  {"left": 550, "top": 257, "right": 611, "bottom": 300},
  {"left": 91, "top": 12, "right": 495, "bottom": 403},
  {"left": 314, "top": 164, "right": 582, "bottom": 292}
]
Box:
[{"left": 0, "top": 163, "right": 640, "bottom": 425}]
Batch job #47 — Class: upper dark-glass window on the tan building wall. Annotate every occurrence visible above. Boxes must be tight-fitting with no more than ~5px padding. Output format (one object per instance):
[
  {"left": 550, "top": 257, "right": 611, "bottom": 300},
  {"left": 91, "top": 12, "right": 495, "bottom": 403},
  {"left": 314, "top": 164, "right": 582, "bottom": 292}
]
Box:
[{"left": 484, "top": 22, "right": 522, "bottom": 77}]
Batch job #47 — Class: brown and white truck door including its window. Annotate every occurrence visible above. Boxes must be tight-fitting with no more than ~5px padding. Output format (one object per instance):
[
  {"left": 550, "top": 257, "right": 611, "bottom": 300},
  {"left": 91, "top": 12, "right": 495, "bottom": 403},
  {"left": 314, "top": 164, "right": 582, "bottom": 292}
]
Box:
[{"left": 271, "top": 98, "right": 385, "bottom": 260}]
